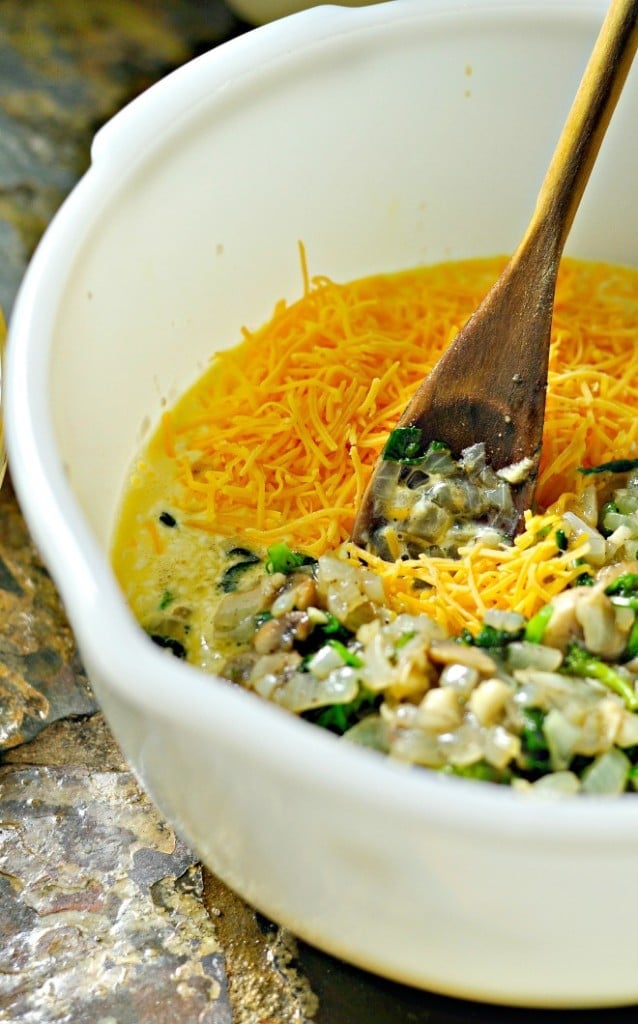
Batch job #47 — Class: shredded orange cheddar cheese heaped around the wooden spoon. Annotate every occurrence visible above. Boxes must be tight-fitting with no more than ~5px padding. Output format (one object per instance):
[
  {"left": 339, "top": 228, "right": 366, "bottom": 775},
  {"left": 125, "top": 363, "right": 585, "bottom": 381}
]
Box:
[{"left": 137, "top": 258, "right": 638, "bottom": 634}]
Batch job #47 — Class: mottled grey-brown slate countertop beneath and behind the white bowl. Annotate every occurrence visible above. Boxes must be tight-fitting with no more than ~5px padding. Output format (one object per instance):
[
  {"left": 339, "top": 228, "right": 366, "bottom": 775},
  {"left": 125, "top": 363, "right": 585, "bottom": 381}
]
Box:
[{"left": 0, "top": 0, "right": 635, "bottom": 1024}]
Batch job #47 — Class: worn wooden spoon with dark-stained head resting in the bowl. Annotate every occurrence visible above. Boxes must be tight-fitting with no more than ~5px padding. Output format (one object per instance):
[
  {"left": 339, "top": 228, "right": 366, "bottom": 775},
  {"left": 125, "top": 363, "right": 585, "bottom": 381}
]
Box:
[{"left": 352, "top": 0, "right": 638, "bottom": 547}]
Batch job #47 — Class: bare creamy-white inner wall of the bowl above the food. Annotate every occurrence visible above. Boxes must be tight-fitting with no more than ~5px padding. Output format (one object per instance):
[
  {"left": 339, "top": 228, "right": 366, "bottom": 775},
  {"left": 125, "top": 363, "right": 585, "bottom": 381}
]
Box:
[{"left": 46, "top": 3, "right": 638, "bottom": 545}]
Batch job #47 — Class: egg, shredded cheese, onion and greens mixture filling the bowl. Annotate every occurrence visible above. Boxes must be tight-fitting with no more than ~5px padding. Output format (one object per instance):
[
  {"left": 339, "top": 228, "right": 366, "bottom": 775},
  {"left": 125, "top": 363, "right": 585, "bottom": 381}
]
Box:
[{"left": 113, "top": 258, "right": 638, "bottom": 795}]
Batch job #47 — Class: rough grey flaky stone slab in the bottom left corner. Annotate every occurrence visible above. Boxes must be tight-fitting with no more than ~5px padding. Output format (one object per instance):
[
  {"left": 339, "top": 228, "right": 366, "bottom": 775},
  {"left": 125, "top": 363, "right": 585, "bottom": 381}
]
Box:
[{"left": 0, "top": 766, "right": 231, "bottom": 1024}]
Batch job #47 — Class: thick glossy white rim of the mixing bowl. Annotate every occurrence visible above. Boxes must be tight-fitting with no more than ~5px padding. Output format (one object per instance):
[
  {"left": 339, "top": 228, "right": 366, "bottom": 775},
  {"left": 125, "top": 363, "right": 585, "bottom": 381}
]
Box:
[{"left": 5, "top": 0, "right": 638, "bottom": 846}]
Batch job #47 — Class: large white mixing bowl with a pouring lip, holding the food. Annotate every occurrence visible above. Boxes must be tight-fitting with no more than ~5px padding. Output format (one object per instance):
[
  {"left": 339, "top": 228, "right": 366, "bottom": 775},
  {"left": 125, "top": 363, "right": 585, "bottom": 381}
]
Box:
[{"left": 6, "top": 0, "right": 638, "bottom": 1007}]
